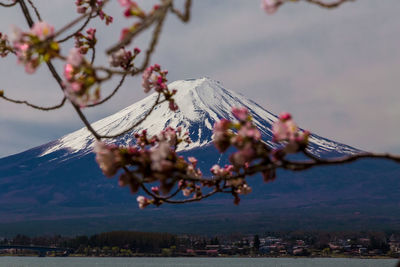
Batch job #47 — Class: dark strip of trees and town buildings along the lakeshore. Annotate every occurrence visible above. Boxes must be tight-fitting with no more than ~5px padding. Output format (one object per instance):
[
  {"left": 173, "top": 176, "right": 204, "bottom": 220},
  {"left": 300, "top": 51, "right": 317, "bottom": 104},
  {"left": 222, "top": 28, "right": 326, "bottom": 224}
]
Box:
[{"left": 0, "top": 231, "right": 400, "bottom": 258}]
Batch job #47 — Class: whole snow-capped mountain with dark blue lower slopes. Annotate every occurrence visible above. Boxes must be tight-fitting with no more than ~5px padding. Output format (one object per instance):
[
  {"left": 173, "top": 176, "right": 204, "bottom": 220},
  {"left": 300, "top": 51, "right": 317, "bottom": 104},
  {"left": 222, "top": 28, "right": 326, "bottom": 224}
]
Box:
[{"left": 0, "top": 78, "right": 400, "bottom": 236}]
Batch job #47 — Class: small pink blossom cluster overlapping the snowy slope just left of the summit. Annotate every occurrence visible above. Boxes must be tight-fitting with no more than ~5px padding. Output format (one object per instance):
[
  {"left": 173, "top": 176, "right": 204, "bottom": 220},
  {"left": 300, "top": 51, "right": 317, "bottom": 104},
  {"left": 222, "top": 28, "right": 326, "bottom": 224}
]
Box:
[{"left": 142, "top": 64, "right": 178, "bottom": 111}]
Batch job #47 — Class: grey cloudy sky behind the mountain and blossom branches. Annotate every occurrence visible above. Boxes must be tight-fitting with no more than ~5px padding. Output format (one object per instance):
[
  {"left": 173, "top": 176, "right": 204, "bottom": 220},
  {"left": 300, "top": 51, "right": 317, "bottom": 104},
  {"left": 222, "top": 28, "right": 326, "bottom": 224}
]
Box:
[{"left": 0, "top": 0, "right": 400, "bottom": 157}]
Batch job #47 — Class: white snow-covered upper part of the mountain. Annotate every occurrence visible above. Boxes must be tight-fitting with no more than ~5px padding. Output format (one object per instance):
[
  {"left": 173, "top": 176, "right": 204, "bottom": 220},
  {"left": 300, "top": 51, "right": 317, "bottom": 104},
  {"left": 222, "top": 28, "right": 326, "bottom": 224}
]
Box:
[{"left": 41, "top": 78, "right": 359, "bottom": 156}]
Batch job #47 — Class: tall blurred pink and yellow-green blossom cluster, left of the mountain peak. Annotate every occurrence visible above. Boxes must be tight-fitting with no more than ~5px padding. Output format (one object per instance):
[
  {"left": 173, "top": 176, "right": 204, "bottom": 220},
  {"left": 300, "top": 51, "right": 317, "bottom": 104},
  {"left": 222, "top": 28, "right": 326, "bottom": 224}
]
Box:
[{"left": 63, "top": 48, "right": 100, "bottom": 107}]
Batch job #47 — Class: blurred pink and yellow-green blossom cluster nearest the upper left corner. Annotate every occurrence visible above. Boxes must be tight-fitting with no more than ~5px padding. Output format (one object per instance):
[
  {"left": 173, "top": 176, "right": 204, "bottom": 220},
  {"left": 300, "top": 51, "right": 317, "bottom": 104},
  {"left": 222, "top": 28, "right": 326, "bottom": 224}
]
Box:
[{"left": 12, "top": 21, "right": 60, "bottom": 74}]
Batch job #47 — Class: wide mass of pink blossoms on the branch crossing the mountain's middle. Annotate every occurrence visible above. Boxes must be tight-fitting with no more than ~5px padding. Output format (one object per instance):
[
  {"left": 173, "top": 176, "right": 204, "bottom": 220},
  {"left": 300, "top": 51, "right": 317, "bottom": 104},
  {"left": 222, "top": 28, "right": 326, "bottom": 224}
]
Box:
[{"left": 94, "top": 104, "right": 309, "bottom": 209}]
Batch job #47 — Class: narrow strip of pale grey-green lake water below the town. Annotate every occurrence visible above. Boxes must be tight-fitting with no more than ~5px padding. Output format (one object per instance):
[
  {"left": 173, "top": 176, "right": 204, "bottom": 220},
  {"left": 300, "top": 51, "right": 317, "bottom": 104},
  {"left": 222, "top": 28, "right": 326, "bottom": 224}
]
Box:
[{"left": 0, "top": 257, "right": 397, "bottom": 267}]
